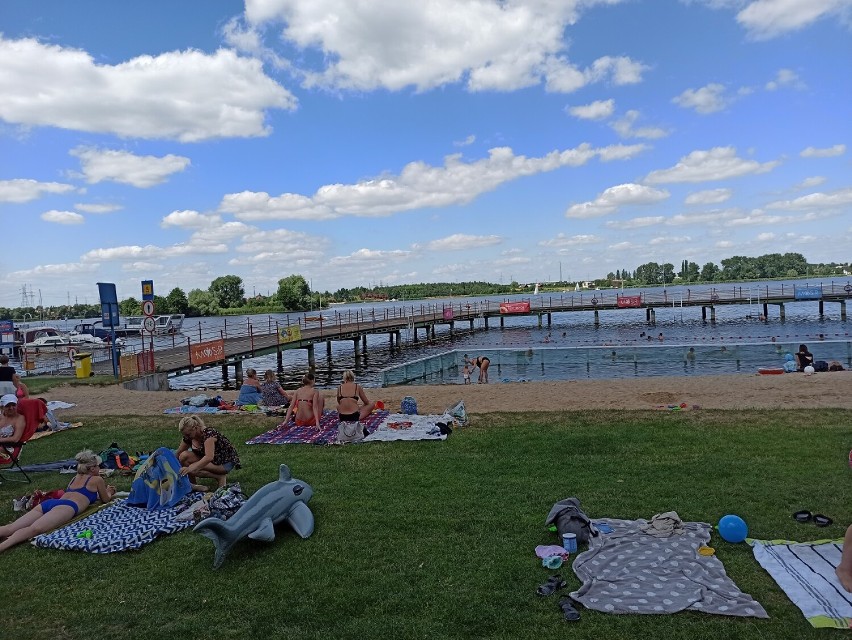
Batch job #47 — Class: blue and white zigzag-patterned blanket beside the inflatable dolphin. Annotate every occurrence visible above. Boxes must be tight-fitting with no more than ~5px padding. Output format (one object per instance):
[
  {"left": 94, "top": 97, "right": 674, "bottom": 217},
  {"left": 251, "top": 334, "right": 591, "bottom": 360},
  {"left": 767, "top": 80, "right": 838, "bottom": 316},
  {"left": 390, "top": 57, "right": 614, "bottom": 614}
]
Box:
[{"left": 32, "top": 493, "right": 202, "bottom": 553}]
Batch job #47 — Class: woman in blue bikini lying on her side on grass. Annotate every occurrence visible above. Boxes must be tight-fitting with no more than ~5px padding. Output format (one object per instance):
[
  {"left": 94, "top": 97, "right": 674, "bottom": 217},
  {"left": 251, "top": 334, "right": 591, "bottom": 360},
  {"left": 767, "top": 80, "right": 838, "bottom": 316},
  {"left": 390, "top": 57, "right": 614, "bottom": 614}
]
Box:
[{"left": 0, "top": 449, "right": 115, "bottom": 552}]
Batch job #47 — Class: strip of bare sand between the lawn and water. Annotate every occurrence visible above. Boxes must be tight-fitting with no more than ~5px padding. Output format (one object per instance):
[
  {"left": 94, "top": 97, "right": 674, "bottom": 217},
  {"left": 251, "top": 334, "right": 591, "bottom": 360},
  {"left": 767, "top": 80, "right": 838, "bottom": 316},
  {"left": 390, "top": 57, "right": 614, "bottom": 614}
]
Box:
[{"left": 42, "top": 371, "right": 852, "bottom": 420}]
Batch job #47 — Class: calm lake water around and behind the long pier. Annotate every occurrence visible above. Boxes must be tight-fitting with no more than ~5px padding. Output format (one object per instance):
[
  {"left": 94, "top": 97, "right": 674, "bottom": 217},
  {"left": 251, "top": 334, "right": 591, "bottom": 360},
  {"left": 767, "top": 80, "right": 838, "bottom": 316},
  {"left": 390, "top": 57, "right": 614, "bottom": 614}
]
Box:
[{"left": 15, "top": 278, "right": 852, "bottom": 389}]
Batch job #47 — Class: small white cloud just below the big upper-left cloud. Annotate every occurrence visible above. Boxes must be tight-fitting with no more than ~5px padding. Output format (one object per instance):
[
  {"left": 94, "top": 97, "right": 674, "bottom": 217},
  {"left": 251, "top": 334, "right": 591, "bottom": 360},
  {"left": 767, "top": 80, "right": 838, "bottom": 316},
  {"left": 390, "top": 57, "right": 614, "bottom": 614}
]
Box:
[{"left": 69, "top": 147, "right": 190, "bottom": 189}]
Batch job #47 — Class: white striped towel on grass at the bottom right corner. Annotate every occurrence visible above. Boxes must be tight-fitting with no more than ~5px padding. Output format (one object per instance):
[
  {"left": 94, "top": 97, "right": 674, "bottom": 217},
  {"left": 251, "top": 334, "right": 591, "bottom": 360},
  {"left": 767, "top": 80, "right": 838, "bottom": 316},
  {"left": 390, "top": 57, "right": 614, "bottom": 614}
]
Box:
[{"left": 753, "top": 540, "right": 852, "bottom": 629}]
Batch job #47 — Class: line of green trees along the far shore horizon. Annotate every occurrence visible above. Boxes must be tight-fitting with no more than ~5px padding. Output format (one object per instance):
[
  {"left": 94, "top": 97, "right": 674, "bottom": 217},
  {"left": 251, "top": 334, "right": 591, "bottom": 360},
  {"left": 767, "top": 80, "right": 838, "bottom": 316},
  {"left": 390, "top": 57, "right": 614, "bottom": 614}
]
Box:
[{"left": 0, "top": 253, "right": 849, "bottom": 321}]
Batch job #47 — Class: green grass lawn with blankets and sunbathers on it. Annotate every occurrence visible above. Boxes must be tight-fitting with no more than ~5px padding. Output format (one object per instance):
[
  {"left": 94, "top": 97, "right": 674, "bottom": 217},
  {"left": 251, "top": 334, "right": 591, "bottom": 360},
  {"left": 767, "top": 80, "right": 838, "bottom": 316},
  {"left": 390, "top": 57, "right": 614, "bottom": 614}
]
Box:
[{"left": 0, "top": 410, "right": 852, "bottom": 640}]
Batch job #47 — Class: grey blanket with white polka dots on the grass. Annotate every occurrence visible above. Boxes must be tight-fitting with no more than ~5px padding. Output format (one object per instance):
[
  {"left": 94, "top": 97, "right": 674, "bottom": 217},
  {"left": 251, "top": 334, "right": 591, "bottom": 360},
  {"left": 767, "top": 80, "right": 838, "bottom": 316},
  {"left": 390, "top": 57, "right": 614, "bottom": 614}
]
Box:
[{"left": 571, "top": 519, "right": 769, "bottom": 618}]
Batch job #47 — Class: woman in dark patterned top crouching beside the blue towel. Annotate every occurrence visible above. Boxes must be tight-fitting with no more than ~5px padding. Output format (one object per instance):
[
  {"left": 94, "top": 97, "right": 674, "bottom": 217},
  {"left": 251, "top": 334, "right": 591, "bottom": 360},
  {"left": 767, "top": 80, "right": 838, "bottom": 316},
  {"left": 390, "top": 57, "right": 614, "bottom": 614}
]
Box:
[{"left": 177, "top": 416, "right": 240, "bottom": 491}]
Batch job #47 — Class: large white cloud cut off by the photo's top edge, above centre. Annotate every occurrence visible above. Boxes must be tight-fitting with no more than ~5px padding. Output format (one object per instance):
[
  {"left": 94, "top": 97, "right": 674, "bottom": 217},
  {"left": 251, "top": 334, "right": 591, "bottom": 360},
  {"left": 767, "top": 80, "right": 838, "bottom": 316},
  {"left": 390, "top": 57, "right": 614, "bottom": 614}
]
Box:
[{"left": 237, "top": 0, "right": 647, "bottom": 92}]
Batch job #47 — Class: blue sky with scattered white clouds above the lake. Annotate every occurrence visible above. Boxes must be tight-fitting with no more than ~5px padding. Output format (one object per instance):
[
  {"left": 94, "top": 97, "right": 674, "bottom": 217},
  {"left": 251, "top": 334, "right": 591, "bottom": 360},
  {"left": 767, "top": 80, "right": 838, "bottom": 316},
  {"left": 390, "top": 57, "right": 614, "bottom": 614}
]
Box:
[{"left": 0, "top": 0, "right": 852, "bottom": 306}]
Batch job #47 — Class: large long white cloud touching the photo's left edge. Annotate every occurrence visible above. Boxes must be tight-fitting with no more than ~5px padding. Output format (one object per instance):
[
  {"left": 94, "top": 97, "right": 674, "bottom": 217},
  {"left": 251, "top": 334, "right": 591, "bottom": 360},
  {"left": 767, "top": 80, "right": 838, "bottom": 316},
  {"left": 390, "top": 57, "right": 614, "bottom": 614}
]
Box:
[{"left": 0, "top": 36, "right": 296, "bottom": 142}]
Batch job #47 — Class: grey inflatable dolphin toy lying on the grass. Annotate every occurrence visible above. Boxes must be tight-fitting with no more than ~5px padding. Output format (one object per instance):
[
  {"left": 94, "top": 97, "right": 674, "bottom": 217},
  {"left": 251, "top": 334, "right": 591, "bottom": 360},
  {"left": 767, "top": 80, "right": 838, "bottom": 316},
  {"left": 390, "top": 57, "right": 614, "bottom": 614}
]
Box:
[{"left": 193, "top": 464, "right": 314, "bottom": 569}]
